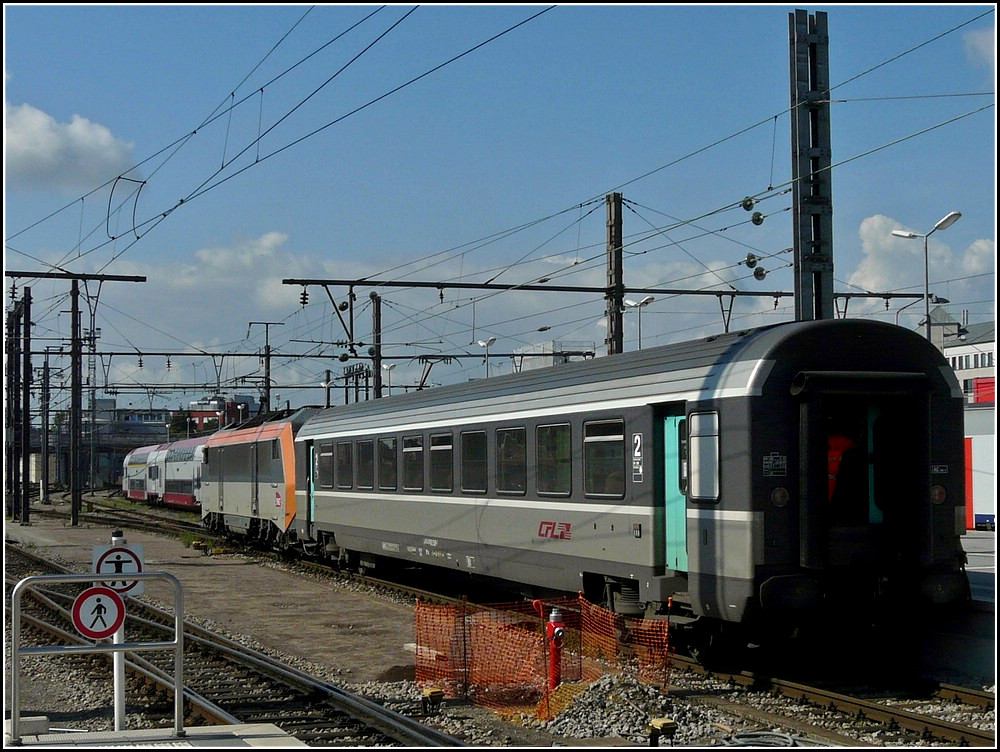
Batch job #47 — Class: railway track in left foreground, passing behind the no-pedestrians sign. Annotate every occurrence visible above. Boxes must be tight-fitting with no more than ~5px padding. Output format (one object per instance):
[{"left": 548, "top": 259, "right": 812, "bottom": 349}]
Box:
[{"left": 6, "top": 546, "right": 464, "bottom": 747}]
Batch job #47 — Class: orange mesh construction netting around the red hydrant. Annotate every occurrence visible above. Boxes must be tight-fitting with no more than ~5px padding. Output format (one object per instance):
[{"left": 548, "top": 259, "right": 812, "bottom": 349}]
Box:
[{"left": 414, "top": 596, "right": 670, "bottom": 720}]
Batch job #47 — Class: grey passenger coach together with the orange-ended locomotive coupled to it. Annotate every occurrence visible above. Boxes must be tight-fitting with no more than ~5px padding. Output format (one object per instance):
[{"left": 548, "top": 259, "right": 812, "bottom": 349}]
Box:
[{"left": 121, "top": 319, "right": 968, "bottom": 648}]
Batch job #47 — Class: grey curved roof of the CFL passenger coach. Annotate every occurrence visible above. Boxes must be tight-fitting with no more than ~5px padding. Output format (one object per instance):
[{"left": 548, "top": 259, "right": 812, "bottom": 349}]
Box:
[{"left": 297, "top": 319, "right": 940, "bottom": 441}]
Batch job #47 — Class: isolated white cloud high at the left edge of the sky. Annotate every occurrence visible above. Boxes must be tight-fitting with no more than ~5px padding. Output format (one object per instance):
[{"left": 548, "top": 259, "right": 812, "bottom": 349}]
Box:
[{"left": 4, "top": 103, "right": 134, "bottom": 192}]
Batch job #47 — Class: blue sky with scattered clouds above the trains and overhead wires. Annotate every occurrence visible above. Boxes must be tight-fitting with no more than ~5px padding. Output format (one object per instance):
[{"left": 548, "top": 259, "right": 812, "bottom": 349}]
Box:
[{"left": 4, "top": 4, "right": 996, "bottom": 407}]
